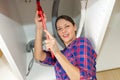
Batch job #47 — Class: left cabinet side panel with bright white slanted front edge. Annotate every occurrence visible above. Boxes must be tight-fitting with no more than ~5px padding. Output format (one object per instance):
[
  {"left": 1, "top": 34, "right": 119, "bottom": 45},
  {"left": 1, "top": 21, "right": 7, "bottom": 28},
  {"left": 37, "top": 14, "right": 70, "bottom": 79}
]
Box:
[{"left": 0, "top": 14, "right": 26, "bottom": 80}]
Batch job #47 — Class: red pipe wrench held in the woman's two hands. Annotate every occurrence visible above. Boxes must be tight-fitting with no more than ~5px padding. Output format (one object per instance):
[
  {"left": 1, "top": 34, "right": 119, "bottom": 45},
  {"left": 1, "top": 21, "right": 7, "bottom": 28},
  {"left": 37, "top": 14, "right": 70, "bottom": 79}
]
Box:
[{"left": 36, "top": 0, "right": 54, "bottom": 58}]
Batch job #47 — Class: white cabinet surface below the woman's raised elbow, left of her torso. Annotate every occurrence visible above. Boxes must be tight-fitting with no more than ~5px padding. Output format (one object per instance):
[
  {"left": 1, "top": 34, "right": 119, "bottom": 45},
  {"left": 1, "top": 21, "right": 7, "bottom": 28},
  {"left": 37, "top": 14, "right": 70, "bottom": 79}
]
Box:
[{"left": 27, "top": 53, "right": 56, "bottom": 80}]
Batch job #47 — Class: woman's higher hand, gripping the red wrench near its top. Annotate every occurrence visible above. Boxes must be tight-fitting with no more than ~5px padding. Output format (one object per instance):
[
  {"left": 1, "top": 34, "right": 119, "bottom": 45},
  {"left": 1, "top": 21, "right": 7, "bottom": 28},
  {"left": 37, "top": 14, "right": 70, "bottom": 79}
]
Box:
[{"left": 35, "top": 11, "right": 47, "bottom": 29}]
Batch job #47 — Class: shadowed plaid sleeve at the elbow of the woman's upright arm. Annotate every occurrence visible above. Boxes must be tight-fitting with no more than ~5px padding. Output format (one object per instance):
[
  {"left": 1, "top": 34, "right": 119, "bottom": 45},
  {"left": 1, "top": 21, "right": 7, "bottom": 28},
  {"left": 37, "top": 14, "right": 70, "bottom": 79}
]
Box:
[{"left": 40, "top": 50, "right": 56, "bottom": 65}]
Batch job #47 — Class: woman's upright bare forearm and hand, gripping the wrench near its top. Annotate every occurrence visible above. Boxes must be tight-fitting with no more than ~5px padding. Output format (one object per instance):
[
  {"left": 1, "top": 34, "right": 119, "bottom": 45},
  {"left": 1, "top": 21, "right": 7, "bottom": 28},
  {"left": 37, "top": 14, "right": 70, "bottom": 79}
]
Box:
[{"left": 34, "top": 13, "right": 46, "bottom": 61}]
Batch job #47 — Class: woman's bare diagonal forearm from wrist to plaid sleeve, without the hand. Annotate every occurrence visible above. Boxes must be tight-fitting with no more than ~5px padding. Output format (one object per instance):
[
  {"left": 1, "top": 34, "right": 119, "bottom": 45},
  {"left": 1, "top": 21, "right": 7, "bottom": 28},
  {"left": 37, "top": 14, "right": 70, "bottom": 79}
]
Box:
[{"left": 55, "top": 52, "right": 80, "bottom": 80}]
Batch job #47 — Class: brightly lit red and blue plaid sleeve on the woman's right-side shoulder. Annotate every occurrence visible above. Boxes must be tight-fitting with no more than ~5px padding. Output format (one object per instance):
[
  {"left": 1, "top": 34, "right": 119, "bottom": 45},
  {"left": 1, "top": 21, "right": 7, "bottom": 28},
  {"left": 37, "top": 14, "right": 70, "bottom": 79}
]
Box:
[{"left": 76, "top": 38, "right": 96, "bottom": 80}]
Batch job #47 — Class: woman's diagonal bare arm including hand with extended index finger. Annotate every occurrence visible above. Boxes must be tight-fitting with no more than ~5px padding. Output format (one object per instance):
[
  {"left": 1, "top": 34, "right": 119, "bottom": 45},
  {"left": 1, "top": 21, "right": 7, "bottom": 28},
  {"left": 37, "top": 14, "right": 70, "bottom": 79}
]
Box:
[{"left": 45, "top": 31, "right": 80, "bottom": 80}]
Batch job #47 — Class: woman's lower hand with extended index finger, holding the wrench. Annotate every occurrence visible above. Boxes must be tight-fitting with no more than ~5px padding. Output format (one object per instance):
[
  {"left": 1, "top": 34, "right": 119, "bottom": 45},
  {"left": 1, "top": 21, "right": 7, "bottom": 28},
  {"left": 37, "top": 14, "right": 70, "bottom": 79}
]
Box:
[{"left": 44, "top": 30, "right": 60, "bottom": 55}]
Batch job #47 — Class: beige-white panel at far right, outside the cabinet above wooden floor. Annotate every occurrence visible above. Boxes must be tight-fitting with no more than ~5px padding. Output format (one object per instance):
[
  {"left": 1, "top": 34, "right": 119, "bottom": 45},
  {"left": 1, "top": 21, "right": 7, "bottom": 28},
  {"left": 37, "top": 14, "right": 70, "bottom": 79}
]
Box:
[{"left": 97, "top": 0, "right": 120, "bottom": 71}]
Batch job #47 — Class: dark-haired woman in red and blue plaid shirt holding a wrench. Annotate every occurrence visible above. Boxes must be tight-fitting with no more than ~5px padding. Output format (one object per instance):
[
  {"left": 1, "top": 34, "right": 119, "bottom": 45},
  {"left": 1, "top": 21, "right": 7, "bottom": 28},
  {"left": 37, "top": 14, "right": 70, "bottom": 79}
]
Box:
[{"left": 34, "top": 12, "right": 96, "bottom": 80}]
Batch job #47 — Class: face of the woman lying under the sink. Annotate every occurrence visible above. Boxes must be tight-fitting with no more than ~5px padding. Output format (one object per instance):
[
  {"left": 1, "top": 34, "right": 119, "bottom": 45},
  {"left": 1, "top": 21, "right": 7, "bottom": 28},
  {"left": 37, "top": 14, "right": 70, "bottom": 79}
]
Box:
[{"left": 56, "top": 19, "right": 76, "bottom": 46}]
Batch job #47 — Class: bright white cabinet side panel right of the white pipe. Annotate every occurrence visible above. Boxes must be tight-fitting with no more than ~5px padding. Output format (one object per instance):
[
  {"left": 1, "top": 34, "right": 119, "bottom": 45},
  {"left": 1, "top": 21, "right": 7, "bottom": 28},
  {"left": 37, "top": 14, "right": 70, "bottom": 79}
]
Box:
[{"left": 85, "top": 0, "right": 115, "bottom": 53}]
